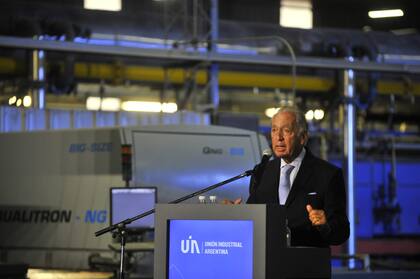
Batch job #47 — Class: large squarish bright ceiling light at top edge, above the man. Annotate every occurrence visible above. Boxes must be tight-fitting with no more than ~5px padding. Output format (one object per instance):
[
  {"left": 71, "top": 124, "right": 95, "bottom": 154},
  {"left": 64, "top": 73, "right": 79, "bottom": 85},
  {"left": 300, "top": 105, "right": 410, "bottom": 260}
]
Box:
[{"left": 280, "top": 0, "right": 313, "bottom": 29}]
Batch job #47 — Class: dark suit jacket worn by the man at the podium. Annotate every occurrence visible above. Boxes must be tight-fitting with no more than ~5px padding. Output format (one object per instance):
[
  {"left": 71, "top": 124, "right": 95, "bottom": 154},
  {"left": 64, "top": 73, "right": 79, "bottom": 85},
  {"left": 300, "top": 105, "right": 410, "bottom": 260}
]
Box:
[{"left": 247, "top": 149, "right": 350, "bottom": 247}]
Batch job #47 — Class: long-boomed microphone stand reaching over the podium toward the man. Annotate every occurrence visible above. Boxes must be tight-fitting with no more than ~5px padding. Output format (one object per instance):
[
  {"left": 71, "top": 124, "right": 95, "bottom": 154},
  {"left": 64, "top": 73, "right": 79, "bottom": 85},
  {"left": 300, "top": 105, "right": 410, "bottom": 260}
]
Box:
[{"left": 95, "top": 170, "right": 254, "bottom": 279}]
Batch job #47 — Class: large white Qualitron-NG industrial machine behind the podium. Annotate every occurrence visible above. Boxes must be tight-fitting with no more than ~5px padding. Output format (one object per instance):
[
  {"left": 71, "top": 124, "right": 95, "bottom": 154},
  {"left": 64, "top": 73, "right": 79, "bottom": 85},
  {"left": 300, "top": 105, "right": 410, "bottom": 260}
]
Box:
[{"left": 0, "top": 125, "right": 268, "bottom": 269}]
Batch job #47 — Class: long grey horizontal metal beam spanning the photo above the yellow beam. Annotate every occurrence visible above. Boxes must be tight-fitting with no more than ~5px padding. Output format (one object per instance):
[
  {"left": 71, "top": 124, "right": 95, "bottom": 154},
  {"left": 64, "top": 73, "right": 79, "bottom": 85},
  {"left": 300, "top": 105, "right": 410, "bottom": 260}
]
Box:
[{"left": 0, "top": 36, "right": 420, "bottom": 74}]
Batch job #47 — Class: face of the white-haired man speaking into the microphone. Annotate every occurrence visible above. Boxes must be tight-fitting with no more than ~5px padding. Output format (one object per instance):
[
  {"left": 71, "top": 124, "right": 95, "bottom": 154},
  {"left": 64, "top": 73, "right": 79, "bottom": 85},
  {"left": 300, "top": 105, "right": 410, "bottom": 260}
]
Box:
[{"left": 271, "top": 112, "right": 306, "bottom": 163}]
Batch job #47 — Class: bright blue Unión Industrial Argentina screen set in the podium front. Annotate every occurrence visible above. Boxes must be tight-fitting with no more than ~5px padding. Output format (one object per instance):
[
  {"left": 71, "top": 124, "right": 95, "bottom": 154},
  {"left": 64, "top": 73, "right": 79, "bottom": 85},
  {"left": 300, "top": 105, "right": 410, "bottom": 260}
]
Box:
[{"left": 167, "top": 220, "right": 254, "bottom": 279}]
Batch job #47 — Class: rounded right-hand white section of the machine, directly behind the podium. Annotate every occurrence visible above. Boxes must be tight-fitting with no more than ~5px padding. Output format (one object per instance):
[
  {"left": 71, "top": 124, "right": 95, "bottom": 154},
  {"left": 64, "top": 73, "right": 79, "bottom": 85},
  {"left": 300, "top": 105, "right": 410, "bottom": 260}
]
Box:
[{"left": 127, "top": 126, "right": 261, "bottom": 203}]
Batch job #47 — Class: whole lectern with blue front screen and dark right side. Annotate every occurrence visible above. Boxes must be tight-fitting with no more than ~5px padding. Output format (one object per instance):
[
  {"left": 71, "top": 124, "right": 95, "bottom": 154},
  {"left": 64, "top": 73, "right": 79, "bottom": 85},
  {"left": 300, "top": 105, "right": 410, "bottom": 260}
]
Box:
[{"left": 154, "top": 204, "right": 331, "bottom": 279}]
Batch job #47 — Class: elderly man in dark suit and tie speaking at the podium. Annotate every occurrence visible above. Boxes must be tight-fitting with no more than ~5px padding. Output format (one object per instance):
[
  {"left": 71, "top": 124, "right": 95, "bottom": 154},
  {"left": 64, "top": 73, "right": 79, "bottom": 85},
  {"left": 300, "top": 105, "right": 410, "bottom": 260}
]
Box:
[{"left": 248, "top": 107, "right": 349, "bottom": 247}]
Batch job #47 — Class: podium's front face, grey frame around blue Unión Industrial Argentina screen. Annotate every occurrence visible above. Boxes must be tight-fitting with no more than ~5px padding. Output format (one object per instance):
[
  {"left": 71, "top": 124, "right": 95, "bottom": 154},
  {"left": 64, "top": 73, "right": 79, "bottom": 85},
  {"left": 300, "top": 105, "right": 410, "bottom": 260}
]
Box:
[{"left": 154, "top": 204, "right": 266, "bottom": 279}]
